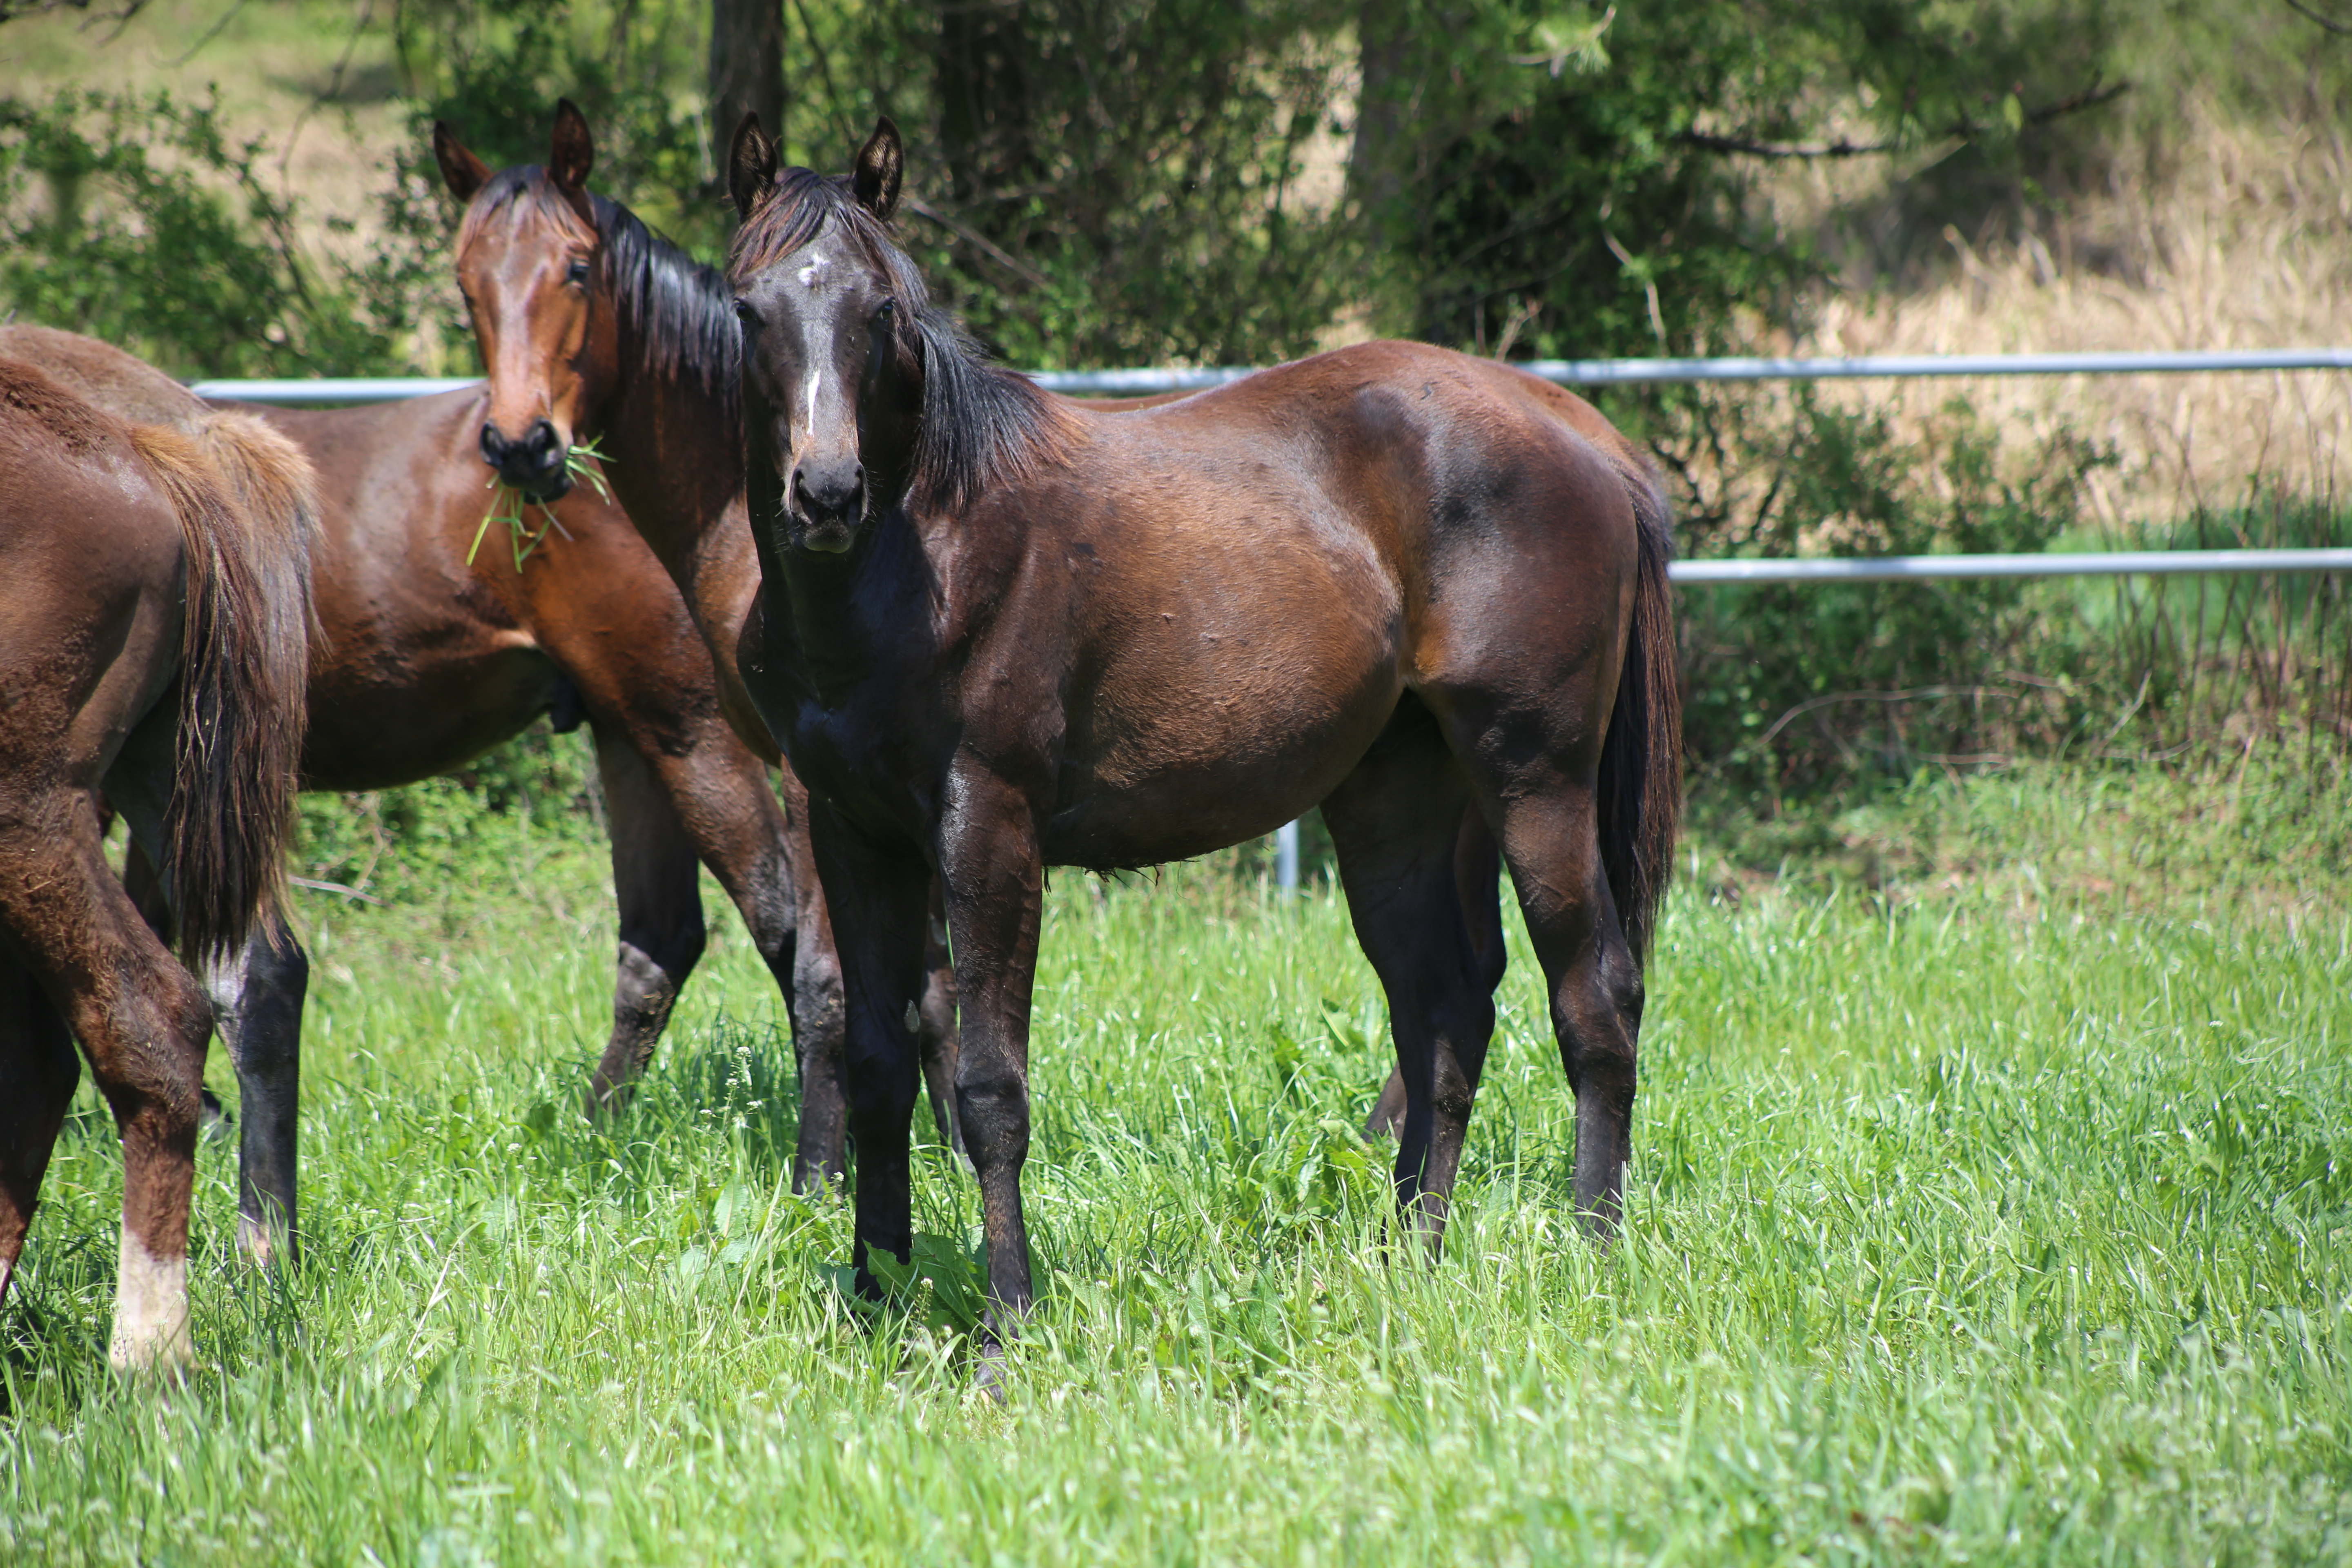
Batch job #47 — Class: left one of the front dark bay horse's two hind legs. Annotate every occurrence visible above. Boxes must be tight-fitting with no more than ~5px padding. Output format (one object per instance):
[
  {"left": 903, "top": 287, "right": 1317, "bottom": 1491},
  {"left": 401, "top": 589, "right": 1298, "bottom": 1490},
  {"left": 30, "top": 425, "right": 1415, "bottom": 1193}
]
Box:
[{"left": 1324, "top": 724, "right": 1501, "bottom": 1246}]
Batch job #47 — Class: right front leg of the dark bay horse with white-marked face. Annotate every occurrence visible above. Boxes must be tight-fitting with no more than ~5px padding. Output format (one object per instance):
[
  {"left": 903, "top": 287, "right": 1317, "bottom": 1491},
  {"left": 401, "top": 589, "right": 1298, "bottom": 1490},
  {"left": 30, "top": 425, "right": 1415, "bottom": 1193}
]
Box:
[{"left": 938, "top": 766, "right": 1044, "bottom": 1342}]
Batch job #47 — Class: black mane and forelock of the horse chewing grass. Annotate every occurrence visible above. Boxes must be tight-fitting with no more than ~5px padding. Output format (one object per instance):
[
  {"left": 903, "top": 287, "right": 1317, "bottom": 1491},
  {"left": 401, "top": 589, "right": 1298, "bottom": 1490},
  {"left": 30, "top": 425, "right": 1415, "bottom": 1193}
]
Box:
[{"left": 459, "top": 165, "right": 743, "bottom": 430}]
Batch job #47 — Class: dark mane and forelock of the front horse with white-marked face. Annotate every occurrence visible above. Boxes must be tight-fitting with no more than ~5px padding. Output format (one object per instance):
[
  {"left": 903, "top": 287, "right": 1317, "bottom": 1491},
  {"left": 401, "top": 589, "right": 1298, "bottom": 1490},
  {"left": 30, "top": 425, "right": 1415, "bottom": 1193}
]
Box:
[{"left": 727, "top": 169, "right": 1073, "bottom": 510}]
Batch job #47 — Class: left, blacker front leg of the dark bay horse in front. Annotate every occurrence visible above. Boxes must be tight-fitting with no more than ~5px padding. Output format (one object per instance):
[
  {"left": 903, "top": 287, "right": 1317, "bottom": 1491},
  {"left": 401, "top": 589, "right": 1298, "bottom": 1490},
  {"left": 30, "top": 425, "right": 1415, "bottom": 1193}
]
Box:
[{"left": 809, "top": 797, "right": 931, "bottom": 1300}]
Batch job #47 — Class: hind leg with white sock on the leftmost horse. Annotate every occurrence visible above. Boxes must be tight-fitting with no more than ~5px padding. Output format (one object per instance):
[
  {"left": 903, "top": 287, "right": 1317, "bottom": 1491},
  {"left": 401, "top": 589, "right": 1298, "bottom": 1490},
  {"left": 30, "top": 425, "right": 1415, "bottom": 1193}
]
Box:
[{"left": 0, "top": 795, "right": 212, "bottom": 1370}]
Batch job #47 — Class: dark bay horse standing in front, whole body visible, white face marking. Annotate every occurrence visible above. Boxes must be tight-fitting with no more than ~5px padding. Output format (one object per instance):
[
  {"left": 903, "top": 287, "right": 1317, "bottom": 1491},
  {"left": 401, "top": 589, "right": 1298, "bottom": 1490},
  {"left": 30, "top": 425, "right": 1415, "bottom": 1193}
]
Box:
[{"left": 727, "top": 118, "right": 1679, "bottom": 1354}]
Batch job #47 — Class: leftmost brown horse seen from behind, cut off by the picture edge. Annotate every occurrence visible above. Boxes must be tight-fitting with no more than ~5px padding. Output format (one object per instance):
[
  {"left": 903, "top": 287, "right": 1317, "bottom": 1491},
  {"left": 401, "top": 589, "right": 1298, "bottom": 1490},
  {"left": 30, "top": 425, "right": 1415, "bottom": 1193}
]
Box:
[{"left": 0, "top": 345, "right": 310, "bottom": 1368}]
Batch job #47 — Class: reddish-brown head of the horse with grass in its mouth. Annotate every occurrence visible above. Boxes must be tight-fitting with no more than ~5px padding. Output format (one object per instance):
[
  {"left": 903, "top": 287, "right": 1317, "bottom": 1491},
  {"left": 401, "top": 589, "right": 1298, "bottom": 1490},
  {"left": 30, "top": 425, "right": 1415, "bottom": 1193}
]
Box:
[{"left": 433, "top": 99, "right": 621, "bottom": 501}]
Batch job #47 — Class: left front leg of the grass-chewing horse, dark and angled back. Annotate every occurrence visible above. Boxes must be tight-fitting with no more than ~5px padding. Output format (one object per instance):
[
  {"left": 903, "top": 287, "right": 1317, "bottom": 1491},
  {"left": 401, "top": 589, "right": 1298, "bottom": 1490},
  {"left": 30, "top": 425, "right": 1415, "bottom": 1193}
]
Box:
[{"left": 588, "top": 726, "right": 703, "bottom": 1114}]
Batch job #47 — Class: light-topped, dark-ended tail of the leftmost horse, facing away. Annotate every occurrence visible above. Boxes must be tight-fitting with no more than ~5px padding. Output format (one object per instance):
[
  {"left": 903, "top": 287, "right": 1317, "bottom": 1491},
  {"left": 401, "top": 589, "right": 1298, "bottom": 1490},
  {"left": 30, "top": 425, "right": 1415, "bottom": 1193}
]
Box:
[{"left": 129, "top": 414, "right": 318, "bottom": 964}]
